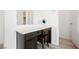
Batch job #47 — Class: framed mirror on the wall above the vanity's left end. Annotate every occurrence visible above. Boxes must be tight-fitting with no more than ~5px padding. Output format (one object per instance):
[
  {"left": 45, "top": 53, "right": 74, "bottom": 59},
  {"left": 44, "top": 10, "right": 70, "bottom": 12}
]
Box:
[{"left": 17, "top": 10, "right": 33, "bottom": 25}]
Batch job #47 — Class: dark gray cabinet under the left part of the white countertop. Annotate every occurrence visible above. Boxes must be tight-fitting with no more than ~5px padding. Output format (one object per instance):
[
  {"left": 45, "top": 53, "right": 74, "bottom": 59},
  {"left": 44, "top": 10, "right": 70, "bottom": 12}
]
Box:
[{"left": 16, "top": 31, "right": 40, "bottom": 49}]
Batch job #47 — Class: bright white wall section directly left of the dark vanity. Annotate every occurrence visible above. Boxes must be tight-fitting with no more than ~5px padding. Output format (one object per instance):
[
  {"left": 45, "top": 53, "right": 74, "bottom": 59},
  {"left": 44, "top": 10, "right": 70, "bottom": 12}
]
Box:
[{"left": 4, "top": 10, "right": 17, "bottom": 49}]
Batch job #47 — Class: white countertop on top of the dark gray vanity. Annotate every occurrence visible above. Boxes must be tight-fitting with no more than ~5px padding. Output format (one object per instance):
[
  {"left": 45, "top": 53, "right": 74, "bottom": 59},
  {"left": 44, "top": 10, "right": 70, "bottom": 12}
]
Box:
[{"left": 16, "top": 24, "right": 52, "bottom": 34}]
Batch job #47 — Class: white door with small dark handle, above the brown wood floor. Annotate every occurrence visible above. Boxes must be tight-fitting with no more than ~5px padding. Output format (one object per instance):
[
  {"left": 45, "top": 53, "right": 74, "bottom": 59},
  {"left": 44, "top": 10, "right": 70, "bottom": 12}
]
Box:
[{"left": 59, "top": 10, "right": 72, "bottom": 39}]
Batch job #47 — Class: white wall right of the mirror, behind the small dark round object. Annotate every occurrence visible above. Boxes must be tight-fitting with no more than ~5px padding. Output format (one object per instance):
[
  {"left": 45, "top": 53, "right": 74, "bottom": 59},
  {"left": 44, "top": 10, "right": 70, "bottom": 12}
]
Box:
[{"left": 33, "top": 10, "right": 59, "bottom": 45}]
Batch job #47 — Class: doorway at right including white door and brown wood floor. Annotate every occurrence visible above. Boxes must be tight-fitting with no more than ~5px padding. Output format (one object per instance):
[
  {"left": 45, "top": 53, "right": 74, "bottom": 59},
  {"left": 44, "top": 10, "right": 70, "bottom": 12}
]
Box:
[{"left": 59, "top": 10, "right": 76, "bottom": 49}]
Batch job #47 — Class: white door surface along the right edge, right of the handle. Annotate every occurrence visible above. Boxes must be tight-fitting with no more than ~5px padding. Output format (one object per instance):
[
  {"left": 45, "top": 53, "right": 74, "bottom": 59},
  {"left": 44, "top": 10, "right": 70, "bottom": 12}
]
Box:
[{"left": 72, "top": 10, "right": 79, "bottom": 41}]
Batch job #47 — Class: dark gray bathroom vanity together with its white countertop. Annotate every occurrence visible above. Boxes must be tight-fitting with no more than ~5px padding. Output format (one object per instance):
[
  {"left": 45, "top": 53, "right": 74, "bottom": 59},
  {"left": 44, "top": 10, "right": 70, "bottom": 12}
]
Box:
[{"left": 16, "top": 25, "right": 51, "bottom": 49}]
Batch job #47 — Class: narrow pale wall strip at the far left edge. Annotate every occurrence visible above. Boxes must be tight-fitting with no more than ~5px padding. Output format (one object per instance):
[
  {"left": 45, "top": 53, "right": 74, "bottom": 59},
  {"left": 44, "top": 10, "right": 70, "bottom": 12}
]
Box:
[{"left": 0, "top": 10, "right": 4, "bottom": 43}]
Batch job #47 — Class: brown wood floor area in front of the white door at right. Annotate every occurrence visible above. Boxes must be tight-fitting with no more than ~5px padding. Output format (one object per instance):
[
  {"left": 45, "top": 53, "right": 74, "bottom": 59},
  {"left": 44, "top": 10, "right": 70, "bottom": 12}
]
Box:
[{"left": 59, "top": 38, "right": 77, "bottom": 49}]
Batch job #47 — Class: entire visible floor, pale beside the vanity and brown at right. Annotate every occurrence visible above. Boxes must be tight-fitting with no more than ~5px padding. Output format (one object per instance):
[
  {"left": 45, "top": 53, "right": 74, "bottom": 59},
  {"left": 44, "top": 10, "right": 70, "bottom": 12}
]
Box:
[{"left": 0, "top": 38, "right": 77, "bottom": 49}]
